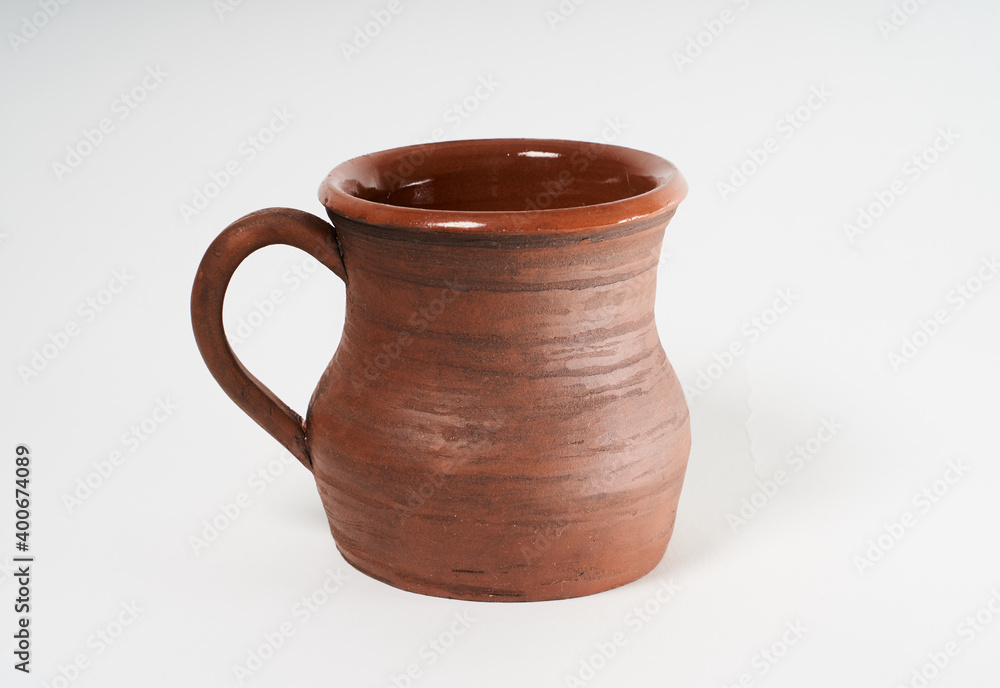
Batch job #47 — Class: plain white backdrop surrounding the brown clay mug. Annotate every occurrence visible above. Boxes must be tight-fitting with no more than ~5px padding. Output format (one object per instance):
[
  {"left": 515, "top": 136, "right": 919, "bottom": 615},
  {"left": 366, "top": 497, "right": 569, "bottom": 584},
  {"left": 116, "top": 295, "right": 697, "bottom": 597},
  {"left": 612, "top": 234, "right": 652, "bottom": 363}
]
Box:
[{"left": 0, "top": 0, "right": 1000, "bottom": 688}]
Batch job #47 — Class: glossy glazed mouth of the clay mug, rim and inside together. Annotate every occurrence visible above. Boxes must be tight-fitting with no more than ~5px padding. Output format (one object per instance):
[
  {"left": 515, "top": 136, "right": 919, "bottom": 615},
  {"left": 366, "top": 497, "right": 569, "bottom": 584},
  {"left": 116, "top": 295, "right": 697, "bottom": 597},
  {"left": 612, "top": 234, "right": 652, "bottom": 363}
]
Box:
[{"left": 319, "top": 139, "right": 687, "bottom": 229}]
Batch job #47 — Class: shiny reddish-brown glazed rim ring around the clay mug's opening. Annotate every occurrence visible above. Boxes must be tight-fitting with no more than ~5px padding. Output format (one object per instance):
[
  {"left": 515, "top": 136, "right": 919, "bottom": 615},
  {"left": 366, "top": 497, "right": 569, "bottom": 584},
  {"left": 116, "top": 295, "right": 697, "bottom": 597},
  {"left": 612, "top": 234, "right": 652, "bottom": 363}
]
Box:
[{"left": 319, "top": 138, "right": 688, "bottom": 234}]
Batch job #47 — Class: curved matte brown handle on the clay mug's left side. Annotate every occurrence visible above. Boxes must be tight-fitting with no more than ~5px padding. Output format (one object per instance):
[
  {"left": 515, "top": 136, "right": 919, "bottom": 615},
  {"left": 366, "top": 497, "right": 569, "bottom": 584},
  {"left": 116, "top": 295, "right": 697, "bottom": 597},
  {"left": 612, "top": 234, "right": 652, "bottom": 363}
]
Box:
[{"left": 191, "top": 208, "right": 347, "bottom": 471}]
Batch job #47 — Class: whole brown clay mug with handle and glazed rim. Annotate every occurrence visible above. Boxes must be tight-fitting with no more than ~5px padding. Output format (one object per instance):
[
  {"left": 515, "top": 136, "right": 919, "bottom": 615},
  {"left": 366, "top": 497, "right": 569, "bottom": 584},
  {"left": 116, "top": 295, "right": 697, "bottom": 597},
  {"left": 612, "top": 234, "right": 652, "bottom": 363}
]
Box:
[{"left": 192, "top": 139, "right": 690, "bottom": 601}]
